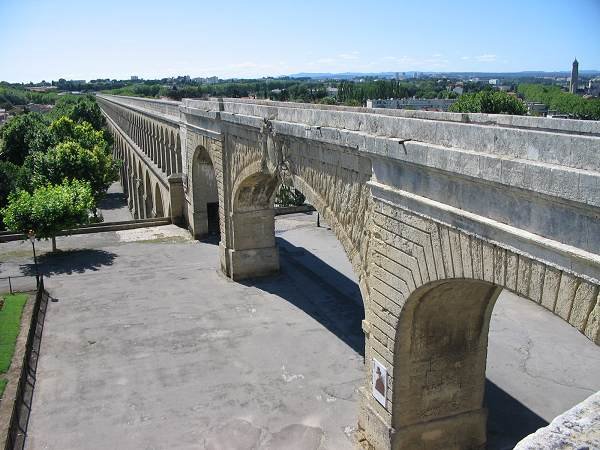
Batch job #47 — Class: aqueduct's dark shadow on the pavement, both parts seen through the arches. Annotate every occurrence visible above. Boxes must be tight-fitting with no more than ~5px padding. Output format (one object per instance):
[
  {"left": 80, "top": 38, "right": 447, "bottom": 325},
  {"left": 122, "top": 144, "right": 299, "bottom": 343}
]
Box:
[{"left": 243, "top": 238, "right": 548, "bottom": 450}]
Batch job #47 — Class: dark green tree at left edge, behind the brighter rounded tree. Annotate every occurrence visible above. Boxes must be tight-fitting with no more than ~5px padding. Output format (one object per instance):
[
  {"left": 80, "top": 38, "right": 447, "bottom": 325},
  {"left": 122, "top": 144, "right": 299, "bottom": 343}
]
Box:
[{"left": 0, "top": 113, "right": 52, "bottom": 166}]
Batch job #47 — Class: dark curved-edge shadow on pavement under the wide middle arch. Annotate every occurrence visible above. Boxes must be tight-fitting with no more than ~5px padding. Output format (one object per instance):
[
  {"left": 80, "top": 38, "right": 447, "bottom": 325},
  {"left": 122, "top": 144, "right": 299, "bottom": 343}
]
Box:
[{"left": 242, "top": 238, "right": 365, "bottom": 356}]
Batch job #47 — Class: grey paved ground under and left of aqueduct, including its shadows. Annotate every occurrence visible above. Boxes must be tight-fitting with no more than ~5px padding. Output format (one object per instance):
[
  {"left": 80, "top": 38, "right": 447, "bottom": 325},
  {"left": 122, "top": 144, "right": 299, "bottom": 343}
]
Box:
[{"left": 0, "top": 189, "right": 600, "bottom": 449}]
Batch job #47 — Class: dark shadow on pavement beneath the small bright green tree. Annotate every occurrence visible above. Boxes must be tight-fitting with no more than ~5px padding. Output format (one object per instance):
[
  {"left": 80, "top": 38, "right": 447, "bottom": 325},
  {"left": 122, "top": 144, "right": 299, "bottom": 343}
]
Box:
[{"left": 21, "top": 249, "right": 117, "bottom": 276}]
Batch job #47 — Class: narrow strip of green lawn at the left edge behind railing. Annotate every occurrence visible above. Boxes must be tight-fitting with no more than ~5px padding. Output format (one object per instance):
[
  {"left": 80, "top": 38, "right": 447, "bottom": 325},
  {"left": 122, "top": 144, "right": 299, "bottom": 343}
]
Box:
[{"left": 0, "top": 294, "right": 28, "bottom": 397}]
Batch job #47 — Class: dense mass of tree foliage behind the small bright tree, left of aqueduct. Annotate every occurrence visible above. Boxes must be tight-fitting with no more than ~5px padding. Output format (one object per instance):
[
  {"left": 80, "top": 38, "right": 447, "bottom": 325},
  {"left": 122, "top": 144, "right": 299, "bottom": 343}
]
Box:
[{"left": 0, "top": 96, "right": 119, "bottom": 228}]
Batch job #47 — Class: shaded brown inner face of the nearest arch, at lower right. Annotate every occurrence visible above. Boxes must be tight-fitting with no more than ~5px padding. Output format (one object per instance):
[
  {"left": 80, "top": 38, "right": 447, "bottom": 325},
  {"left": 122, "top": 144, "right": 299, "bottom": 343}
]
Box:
[{"left": 388, "top": 279, "right": 502, "bottom": 449}]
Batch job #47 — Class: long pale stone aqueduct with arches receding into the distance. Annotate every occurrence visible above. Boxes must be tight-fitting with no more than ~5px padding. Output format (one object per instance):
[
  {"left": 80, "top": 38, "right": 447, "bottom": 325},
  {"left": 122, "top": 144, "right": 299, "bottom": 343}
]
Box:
[{"left": 98, "top": 95, "right": 600, "bottom": 449}]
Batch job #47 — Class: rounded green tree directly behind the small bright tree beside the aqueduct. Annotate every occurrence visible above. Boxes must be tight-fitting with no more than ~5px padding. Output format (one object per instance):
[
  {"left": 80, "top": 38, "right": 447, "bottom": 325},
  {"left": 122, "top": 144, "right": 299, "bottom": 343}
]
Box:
[{"left": 32, "top": 140, "right": 119, "bottom": 201}]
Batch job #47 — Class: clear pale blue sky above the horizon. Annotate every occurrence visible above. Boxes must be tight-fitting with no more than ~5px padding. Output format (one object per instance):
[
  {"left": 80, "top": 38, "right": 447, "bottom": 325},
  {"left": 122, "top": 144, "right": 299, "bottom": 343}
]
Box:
[{"left": 0, "top": 0, "right": 600, "bottom": 82}]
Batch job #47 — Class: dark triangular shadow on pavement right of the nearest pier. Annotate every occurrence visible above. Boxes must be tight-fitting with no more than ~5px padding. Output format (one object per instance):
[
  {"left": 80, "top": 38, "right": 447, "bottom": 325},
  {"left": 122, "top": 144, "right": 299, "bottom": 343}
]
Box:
[{"left": 485, "top": 380, "right": 548, "bottom": 450}]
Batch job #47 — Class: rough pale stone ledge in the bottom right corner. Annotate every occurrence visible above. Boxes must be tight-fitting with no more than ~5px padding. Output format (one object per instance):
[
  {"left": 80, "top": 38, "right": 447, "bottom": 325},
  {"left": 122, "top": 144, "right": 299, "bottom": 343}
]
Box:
[{"left": 515, "top": 391, "right": 600, "bottom": 450}]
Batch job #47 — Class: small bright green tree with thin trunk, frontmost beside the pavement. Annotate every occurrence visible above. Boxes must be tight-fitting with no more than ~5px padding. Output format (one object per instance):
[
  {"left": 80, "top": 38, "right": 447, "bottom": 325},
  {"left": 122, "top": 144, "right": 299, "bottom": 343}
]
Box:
[{"left": 2, "top": 180, "right": 95, "bottom": 251}]
